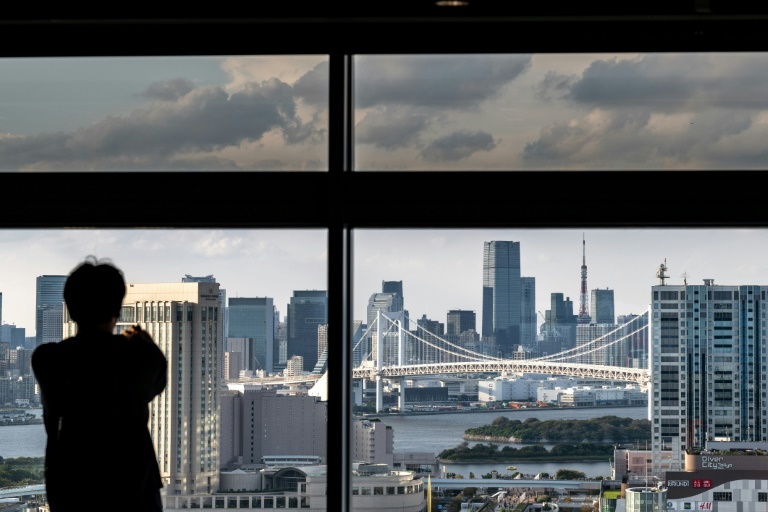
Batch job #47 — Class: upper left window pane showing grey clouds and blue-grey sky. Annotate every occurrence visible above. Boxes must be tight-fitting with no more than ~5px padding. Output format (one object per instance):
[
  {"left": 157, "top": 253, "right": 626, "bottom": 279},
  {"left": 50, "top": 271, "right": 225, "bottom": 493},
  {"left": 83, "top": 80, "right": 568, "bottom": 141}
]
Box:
[{"left": 0, "top": 56, "right": 328, "bottom": 172}]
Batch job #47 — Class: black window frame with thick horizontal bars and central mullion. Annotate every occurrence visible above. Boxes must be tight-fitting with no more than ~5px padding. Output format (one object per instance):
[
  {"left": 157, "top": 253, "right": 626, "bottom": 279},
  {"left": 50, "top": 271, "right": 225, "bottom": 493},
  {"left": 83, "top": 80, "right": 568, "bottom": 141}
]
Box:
[{"left": 0, "top": 9, "right": 768, "bottom": 511}]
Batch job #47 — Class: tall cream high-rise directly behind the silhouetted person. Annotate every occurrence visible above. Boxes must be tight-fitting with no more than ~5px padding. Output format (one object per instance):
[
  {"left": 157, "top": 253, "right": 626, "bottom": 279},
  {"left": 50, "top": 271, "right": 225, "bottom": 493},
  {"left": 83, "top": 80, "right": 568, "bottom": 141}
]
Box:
[{"left": 65, "top": 282, "right": 222, "bottom": 496}]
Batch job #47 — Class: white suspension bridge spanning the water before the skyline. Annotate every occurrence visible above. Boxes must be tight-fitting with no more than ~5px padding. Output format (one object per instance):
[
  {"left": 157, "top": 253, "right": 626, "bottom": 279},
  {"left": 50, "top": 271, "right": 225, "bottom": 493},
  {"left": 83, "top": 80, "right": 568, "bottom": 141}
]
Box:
[{"left": 352, "top": 311, "right": 651, "bottom": 410}]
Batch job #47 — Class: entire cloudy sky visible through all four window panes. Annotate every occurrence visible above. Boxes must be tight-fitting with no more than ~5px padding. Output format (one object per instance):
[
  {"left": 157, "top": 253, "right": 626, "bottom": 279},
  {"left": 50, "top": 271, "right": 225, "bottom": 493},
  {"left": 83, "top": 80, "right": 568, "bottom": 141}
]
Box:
[{"left": 0, "top": 52, "right": 768, "bottom": 335}]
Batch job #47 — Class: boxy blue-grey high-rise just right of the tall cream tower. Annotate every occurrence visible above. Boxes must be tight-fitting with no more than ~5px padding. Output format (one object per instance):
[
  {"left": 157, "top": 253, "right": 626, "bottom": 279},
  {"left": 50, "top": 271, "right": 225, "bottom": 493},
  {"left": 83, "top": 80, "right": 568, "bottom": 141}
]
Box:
[{"left": 227, "top": 297, "right": 279, "bottom": 373}]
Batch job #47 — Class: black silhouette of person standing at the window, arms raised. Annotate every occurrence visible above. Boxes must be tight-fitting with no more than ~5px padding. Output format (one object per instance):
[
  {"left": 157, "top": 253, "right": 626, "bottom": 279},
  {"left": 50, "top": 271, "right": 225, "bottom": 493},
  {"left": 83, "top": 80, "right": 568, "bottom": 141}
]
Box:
[{"left": 31, "top": 256, "right": 168, "bottom": 512}]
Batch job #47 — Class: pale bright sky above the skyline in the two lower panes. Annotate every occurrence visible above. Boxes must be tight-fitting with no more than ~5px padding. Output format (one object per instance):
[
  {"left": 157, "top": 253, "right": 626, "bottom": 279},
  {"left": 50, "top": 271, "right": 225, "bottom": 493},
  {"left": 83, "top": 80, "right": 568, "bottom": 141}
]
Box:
[{"left": 0, "top": 228, "right": 768, "bottom": 336}]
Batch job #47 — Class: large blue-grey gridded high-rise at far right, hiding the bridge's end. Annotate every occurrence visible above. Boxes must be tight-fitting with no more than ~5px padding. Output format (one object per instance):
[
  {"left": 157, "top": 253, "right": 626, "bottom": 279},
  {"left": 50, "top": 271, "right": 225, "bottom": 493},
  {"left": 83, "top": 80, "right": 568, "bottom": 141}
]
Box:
[{"left": 649, "top": 279, "right": 768, "bottom": 474}]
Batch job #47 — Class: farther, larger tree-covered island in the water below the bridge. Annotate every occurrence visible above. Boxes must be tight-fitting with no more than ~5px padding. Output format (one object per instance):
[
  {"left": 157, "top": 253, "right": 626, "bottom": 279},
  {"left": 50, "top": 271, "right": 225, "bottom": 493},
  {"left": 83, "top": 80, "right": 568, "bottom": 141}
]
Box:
[{"left": 464, "top": 416, "right": 651, "bottom": 445}]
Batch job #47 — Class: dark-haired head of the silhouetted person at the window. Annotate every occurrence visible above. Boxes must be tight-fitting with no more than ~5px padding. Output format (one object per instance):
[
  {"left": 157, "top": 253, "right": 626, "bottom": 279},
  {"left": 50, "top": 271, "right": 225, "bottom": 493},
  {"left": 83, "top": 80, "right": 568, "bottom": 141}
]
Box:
[{"left": 64, "top": 256, "right": 125, "bottom": 324}]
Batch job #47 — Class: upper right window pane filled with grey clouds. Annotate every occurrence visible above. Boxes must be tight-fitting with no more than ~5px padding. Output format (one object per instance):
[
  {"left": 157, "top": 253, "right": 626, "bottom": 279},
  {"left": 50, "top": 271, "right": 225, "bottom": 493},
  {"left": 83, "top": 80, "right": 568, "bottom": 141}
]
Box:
[{"left": 354, "top": 53, "right": 768, "bottom": 171}]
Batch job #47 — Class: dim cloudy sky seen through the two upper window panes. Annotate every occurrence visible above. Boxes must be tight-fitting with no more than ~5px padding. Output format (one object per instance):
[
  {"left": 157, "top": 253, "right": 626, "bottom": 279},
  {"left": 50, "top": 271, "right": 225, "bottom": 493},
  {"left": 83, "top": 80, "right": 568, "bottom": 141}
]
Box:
[{"left": 0, "top": 53, "right": 768, "bottom": 172}]
